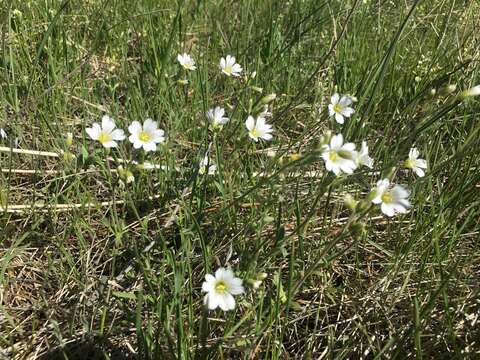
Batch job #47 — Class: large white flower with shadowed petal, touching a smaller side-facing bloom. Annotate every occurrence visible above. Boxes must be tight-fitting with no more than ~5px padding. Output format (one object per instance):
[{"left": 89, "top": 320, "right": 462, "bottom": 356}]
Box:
[{"left": 322, "top": 134, "right": 357, "bottom": 175}]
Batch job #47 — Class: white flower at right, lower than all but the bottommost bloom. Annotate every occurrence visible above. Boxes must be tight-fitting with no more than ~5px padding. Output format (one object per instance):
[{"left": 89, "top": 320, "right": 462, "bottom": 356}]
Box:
[{"left": 372, "top": 179, "right": 411, "bottom": 216}]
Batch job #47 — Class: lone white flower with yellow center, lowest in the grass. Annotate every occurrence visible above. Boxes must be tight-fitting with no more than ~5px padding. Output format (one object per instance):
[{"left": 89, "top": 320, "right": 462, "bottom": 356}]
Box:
[{"left": 202, "top": 268, "right": 245, "bottom": 311}]
